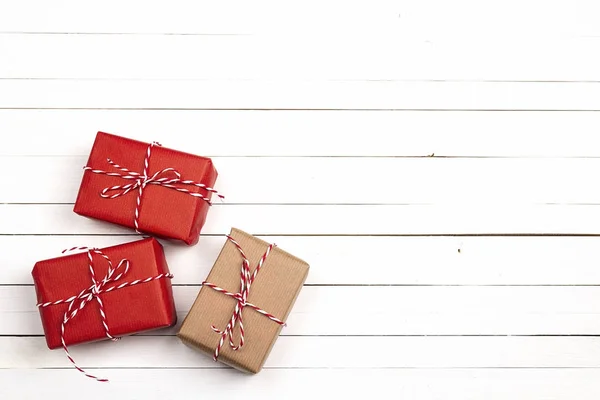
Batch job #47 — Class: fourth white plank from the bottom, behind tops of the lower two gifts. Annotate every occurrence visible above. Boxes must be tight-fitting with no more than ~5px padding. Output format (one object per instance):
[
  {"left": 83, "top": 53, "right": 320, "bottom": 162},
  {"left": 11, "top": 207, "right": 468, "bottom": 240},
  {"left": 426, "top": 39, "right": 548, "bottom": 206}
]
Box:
[{"left": 0, "top": 236, "right": 600, "bottom": 285}]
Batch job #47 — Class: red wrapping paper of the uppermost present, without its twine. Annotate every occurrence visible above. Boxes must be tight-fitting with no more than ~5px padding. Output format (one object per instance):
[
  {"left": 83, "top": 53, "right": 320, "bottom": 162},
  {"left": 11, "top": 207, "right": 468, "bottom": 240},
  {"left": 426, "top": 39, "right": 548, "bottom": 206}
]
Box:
[{"left": 74, "top": 132, "right": 217, "bottom": 245}]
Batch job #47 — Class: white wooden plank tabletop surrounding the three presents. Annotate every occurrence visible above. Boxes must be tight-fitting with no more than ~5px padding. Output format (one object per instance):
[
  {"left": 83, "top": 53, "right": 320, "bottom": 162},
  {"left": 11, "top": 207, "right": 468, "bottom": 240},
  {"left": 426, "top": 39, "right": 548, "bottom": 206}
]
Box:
[{"left": 0, "top": 0, "right": 600, "bottom": 400}]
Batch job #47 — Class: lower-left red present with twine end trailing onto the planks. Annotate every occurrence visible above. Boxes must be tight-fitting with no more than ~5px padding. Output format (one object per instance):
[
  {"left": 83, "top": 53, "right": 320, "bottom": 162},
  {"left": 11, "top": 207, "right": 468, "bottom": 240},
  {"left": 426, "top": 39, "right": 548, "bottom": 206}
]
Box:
[{"left": 32, "top": 238, "right": 177, "bottom": 381}]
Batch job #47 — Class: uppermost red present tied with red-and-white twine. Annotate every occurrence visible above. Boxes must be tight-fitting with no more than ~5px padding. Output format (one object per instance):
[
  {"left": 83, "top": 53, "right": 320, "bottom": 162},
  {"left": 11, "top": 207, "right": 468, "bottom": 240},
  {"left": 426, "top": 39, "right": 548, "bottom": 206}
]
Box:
[{"left": 74, "top": 132, "right": 222, "bottom": 245}]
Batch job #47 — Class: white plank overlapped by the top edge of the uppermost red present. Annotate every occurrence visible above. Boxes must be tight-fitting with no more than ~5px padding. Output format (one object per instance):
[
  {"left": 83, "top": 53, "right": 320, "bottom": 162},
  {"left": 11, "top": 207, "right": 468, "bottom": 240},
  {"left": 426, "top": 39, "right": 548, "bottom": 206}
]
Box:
[{"left": 0, "top": 110, "right": 600, "bottom": 157}]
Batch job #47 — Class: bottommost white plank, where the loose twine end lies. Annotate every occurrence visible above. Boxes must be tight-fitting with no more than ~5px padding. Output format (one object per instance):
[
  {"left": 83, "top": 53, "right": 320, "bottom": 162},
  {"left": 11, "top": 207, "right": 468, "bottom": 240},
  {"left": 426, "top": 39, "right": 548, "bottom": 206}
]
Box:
[{"left": 0, "top": 368, "right": 600, "bottom": 400}]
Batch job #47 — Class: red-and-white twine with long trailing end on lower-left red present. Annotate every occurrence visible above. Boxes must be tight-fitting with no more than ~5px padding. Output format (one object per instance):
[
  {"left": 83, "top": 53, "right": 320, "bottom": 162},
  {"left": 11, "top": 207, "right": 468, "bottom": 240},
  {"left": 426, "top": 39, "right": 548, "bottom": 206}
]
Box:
[{"left": 37, "top": 247, "right": 173, "bottom": 382}]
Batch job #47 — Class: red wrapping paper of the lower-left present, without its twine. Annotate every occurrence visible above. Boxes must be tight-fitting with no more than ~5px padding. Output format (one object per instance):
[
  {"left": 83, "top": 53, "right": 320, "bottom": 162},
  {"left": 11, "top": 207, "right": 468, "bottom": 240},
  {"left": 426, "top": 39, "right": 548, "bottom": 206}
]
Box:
[{"left": 32, "top": 238, "right": 177, "bottom": 349}]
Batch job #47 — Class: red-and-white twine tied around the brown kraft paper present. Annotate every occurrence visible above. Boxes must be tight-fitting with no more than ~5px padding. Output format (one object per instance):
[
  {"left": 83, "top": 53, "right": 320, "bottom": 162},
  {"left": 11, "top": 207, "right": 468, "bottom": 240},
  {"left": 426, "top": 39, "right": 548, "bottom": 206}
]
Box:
[{"left": 202, "top": 236, "right": 285, "bottom": 361}]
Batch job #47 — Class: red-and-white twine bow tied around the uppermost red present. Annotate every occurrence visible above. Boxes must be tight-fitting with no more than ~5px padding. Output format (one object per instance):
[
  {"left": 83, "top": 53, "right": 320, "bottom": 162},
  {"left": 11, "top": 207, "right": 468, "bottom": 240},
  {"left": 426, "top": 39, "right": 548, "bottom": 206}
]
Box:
[{"left": 83, "top": 142, "right": 225, "bottom": 234}]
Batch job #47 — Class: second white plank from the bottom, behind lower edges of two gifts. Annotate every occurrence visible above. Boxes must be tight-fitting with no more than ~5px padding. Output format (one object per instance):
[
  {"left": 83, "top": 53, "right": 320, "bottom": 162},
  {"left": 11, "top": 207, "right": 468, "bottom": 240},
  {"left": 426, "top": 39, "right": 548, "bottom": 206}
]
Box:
[{"left": 0, "top": 336, "right": 600, "bottom": 373}]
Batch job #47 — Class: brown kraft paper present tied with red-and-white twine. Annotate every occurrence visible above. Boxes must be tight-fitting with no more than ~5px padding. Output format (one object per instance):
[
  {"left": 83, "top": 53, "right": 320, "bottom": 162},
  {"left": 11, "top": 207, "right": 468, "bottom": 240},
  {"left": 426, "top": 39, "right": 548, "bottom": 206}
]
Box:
[{"left": 177, "top": 229, "right": 309, "bottom": 373}]
